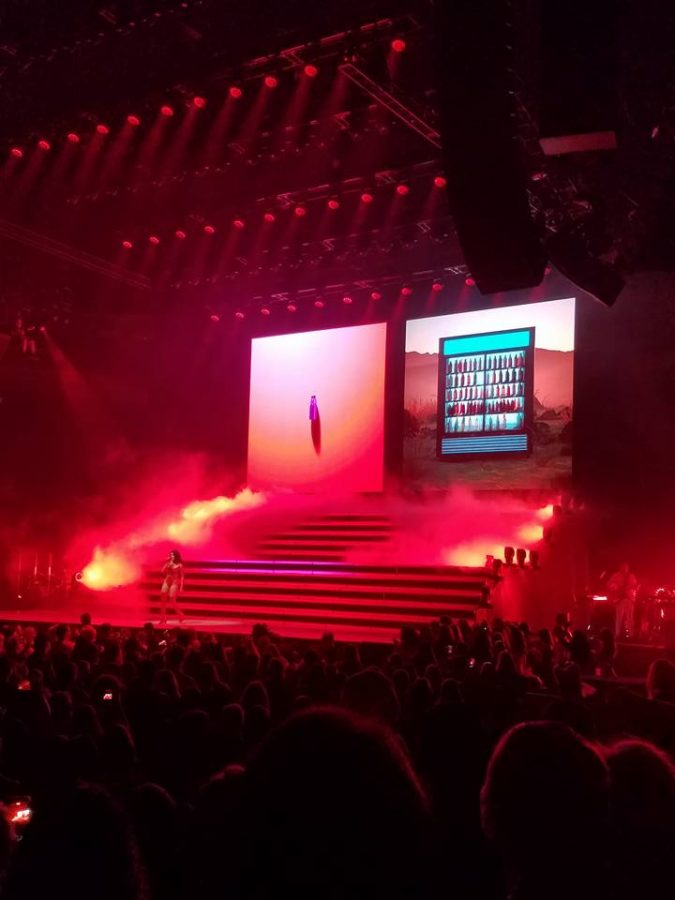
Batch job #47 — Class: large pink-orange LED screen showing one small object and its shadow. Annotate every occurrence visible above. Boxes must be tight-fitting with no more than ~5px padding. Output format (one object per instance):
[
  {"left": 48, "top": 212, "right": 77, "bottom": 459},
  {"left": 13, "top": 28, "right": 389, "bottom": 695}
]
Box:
[{"left": 248, "top": 323, "right": 387, "bottom": 493}]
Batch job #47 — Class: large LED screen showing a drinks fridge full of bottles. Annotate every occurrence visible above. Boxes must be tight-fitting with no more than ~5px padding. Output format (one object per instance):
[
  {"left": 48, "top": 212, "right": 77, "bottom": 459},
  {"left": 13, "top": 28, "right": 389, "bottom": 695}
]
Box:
[{"left": 404, "top": 298, "right": 575, "bottom": 490}]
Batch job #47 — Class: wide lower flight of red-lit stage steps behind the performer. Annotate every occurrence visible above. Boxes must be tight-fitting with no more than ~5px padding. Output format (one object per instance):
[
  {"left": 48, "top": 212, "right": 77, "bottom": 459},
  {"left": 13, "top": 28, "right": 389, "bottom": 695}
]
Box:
[{"left": 143, "top": 559, "right": 492, "bottom": 642}]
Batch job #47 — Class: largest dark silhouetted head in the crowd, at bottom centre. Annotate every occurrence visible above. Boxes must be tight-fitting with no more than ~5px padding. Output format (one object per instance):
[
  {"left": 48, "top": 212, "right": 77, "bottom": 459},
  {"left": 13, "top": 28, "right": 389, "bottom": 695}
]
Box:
[{"left": 235, "top": 709, "right": 429, "bottom": 900}]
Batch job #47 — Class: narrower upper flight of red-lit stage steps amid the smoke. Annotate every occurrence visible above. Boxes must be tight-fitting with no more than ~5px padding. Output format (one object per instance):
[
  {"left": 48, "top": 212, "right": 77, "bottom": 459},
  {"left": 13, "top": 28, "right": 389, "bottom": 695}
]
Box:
[{"left": 256, "top": 515, "right": 392, "bottom": 562}]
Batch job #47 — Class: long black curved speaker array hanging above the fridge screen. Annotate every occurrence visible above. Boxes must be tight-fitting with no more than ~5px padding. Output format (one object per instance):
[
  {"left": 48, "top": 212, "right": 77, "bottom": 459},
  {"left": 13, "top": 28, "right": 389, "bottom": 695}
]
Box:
[{"left": 434, "top": 0, "right": 545, "bottom": 294}]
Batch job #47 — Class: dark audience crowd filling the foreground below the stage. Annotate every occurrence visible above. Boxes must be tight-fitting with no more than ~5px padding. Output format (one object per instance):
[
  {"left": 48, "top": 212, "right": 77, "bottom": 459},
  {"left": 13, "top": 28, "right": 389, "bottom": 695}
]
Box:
[{"left": 0, "top": 615, "right": 675, "bottom": 900}]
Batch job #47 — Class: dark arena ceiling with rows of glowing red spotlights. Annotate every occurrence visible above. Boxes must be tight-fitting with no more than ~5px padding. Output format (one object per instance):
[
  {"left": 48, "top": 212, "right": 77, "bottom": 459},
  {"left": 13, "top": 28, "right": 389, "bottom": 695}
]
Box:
[{"left": 0, "top": 0, "right": 675, "bottom": 322}]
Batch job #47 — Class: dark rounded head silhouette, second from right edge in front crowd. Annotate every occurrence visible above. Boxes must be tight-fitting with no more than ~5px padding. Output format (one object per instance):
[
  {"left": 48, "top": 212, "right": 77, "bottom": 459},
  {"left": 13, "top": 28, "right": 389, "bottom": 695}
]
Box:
[{"left": 481, "top": 722, "right": 609, "bottom": 898}]
